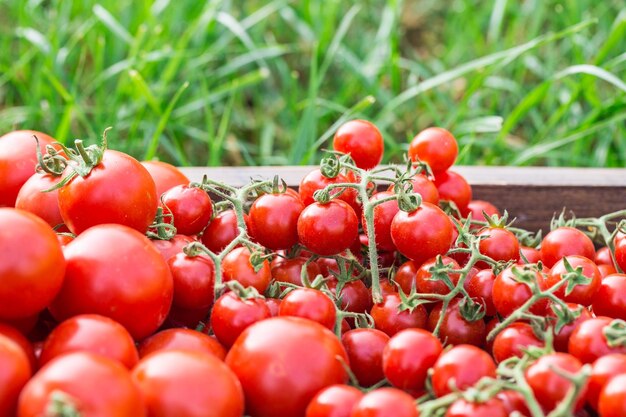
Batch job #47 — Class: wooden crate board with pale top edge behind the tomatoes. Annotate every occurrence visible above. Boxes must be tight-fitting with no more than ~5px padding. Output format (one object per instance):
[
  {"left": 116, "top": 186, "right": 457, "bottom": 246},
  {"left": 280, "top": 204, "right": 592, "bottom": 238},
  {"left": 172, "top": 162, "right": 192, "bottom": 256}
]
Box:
[{"left": 182, "top": 166, "right": 626, "bottom": 231}]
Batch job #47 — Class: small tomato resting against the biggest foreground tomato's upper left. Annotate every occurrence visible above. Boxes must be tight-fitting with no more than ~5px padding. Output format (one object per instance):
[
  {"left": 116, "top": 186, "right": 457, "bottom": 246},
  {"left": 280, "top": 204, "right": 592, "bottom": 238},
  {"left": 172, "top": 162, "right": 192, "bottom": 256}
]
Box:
[{"left": 211, "top": 292, "right": 271, "bottom": 348}]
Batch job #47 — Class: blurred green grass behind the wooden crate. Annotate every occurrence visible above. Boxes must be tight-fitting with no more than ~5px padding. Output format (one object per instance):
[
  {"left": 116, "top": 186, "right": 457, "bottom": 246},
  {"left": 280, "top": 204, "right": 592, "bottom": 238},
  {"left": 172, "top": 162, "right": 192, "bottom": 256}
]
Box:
[{"left": 0, "top": 0, "right": 626, "bottom": 167}]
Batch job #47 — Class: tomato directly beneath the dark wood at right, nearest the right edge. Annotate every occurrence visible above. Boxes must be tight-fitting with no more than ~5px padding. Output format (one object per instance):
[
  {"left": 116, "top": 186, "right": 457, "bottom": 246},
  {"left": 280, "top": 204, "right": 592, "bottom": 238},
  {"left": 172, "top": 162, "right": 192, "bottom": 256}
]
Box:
[{"left": 541, "top": 227, "right": 596, "bottom": 268}]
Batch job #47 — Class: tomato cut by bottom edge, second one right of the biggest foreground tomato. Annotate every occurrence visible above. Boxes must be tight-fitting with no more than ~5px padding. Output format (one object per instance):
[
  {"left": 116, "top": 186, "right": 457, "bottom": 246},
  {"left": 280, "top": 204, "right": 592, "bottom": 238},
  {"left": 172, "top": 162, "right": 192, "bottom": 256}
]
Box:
[{"left": 350, "top": 388, "right": 419, "bottom": 417}]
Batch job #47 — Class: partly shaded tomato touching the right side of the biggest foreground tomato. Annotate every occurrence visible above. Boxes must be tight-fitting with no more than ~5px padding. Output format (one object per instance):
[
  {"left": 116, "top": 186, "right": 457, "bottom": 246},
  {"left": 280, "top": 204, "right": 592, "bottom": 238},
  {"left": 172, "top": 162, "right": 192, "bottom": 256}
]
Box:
[{"left": 341, "top": 328, "right": 389, "bottom": 387}]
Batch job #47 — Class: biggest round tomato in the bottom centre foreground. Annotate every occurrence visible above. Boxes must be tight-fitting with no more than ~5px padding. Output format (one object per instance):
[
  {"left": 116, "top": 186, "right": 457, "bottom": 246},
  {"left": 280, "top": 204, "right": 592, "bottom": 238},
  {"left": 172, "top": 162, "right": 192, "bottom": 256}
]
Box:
[{"left": 226, "top": 317, "right": 348, "bottom": 417}]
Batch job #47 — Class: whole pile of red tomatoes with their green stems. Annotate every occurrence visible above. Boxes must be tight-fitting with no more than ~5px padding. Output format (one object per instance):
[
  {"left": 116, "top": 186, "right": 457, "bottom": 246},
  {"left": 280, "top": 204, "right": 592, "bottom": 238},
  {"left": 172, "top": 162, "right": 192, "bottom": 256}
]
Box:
[{"left": 0, "top": 120, "right": 626, "bottom": 417}]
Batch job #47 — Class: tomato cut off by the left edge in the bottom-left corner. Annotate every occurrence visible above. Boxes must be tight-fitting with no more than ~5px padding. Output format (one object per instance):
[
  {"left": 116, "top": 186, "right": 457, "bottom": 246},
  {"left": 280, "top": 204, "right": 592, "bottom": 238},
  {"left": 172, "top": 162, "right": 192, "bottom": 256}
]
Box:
[{"left": 0, "top": 334, "right": 33, "bottom": 417}]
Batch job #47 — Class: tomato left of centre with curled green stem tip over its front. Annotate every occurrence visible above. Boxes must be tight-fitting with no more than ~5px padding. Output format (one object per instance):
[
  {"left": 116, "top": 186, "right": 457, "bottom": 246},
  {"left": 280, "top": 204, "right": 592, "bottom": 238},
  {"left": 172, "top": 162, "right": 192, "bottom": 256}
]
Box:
[{"left": 222, "top": 247, "right": 272, "bottom": 294}]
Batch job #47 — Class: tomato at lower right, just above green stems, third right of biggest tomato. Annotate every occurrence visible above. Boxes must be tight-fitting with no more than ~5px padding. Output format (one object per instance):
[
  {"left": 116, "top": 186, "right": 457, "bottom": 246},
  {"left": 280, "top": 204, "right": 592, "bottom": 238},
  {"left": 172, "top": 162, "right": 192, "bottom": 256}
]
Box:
[{"left": 432, "top": 345, "right": 496, "bottom": 397}]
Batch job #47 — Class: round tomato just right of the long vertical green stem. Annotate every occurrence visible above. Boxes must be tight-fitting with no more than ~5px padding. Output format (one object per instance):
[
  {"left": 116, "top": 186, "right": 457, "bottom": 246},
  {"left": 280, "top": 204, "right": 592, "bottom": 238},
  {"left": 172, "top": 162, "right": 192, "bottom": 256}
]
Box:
[{"left": 391, "top": 203, "right": 452, "bottom": 265}]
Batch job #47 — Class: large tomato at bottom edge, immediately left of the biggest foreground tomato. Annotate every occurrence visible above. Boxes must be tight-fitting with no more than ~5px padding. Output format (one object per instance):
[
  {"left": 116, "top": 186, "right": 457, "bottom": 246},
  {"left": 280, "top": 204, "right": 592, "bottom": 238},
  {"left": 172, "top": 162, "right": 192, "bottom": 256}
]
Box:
[{"left": 132, "top": 350, "right": 244, "bottom": 417}]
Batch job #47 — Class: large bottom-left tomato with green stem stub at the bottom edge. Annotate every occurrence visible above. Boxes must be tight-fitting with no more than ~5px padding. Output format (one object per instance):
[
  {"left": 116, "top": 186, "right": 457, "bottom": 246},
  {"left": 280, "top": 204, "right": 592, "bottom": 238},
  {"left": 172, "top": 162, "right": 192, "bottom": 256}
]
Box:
[{"left": 17, "top": 352, "right": 146, "bottom": 417}]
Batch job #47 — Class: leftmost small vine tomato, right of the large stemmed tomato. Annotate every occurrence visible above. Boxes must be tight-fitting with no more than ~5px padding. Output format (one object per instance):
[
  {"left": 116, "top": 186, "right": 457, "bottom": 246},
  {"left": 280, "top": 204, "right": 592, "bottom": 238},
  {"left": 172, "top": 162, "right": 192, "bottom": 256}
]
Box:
[{"left": 161, "top": 185, "right": 213, "bottom": 236}]
